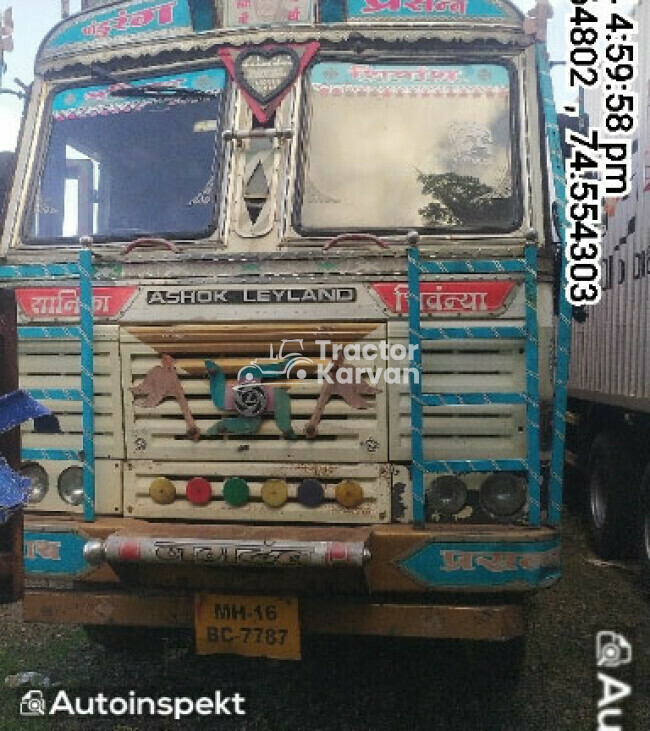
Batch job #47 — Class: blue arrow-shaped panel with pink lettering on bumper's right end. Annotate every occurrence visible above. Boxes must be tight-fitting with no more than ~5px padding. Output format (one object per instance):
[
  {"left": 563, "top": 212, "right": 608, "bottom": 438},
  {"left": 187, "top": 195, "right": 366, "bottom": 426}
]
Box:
[{"left": 398, "top": 537, "right": 561, "bottom": 588}]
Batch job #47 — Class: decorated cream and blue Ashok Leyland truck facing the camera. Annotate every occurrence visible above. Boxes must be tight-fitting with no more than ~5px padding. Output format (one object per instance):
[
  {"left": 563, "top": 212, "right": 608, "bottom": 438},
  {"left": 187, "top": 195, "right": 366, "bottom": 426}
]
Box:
[{"left": 0, "top": 0, "right": 569, "bottom": 658}]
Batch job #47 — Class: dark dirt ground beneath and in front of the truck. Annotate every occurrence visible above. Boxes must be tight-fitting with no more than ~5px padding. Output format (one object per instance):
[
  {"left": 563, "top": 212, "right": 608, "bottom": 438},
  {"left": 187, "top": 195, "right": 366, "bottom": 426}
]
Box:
[{"left": 0, "top": 516, "right": 650, "bottom": 731}]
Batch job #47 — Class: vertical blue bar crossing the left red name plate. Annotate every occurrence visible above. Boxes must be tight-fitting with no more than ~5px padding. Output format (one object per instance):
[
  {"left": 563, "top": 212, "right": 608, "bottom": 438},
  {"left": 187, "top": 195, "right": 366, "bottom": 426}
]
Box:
[{"left": 79, "top": 249, "right": 95, "bottom": 522}]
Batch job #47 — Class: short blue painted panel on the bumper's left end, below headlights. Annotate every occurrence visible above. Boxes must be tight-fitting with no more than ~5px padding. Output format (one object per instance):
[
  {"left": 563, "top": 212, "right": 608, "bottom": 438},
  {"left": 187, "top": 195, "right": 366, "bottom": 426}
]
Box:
[{"left": 24, "top": 531, "right": 93, "bottom": 576}]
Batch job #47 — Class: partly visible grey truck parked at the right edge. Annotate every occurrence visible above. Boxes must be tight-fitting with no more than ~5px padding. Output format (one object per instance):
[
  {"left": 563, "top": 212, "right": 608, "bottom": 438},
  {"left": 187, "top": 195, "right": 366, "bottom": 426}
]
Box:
[{"left": 567, "top": 0, "right": 650, "bottom": 579}]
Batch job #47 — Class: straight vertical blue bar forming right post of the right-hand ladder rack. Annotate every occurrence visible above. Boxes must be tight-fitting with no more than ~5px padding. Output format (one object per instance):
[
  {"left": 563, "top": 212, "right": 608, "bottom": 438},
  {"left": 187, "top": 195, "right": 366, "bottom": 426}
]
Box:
[{"left": 525, "top": 244, "right": 542, "bottom": 526}]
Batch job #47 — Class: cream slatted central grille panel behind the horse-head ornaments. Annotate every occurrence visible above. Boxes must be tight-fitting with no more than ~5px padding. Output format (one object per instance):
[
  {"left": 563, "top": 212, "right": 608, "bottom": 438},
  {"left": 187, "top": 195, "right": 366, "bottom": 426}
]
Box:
[{"left": 121, "top": 323, "right": 388, "bottom": 463}]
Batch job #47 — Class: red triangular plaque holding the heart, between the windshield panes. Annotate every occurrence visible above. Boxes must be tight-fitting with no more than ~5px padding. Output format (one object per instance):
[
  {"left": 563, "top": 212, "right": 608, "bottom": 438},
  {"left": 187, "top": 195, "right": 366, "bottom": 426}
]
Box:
[{"left": 219, "top": 42, "right": 319, "bottom": 124}]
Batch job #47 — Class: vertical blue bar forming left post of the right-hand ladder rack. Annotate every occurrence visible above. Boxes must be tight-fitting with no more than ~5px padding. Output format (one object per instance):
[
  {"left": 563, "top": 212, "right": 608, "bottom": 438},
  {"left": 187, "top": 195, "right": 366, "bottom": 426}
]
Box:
[{"left": 408, "top": 246, "right": 424, "bottom": 523}]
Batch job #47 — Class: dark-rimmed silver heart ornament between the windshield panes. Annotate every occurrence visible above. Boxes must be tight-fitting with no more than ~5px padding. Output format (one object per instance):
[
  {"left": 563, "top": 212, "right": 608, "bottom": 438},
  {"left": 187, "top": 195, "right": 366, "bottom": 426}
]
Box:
[{"left": 235, "top": 47, "right": 300, "bottom": 104}]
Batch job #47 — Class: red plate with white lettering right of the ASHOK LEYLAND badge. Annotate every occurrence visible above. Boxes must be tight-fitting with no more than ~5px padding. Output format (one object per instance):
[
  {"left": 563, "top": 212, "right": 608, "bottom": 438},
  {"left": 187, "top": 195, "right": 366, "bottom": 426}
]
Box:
[{"left": 372, "top": 280, "right": 515, "bottom": 315}]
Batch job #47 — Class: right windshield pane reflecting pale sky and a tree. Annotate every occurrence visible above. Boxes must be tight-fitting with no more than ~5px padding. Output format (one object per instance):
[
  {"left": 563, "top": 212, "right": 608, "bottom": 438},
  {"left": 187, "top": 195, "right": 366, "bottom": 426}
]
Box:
[{"left": 297, "top": 62, "right": 518, "bottom": 231}]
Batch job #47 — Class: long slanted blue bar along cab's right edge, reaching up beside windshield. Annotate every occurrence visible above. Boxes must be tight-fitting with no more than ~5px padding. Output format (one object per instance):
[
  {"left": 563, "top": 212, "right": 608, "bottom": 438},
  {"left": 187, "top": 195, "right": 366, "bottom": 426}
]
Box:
[{"left": 536, "top": 43, "right": 571, "bottom": 525}]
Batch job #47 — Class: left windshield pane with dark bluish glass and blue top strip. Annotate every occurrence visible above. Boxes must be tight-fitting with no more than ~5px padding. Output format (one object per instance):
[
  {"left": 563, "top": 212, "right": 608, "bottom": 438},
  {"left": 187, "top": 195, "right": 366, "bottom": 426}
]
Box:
[{"left": 29, "top": 68, "right": 226, "bottom": 243}]
